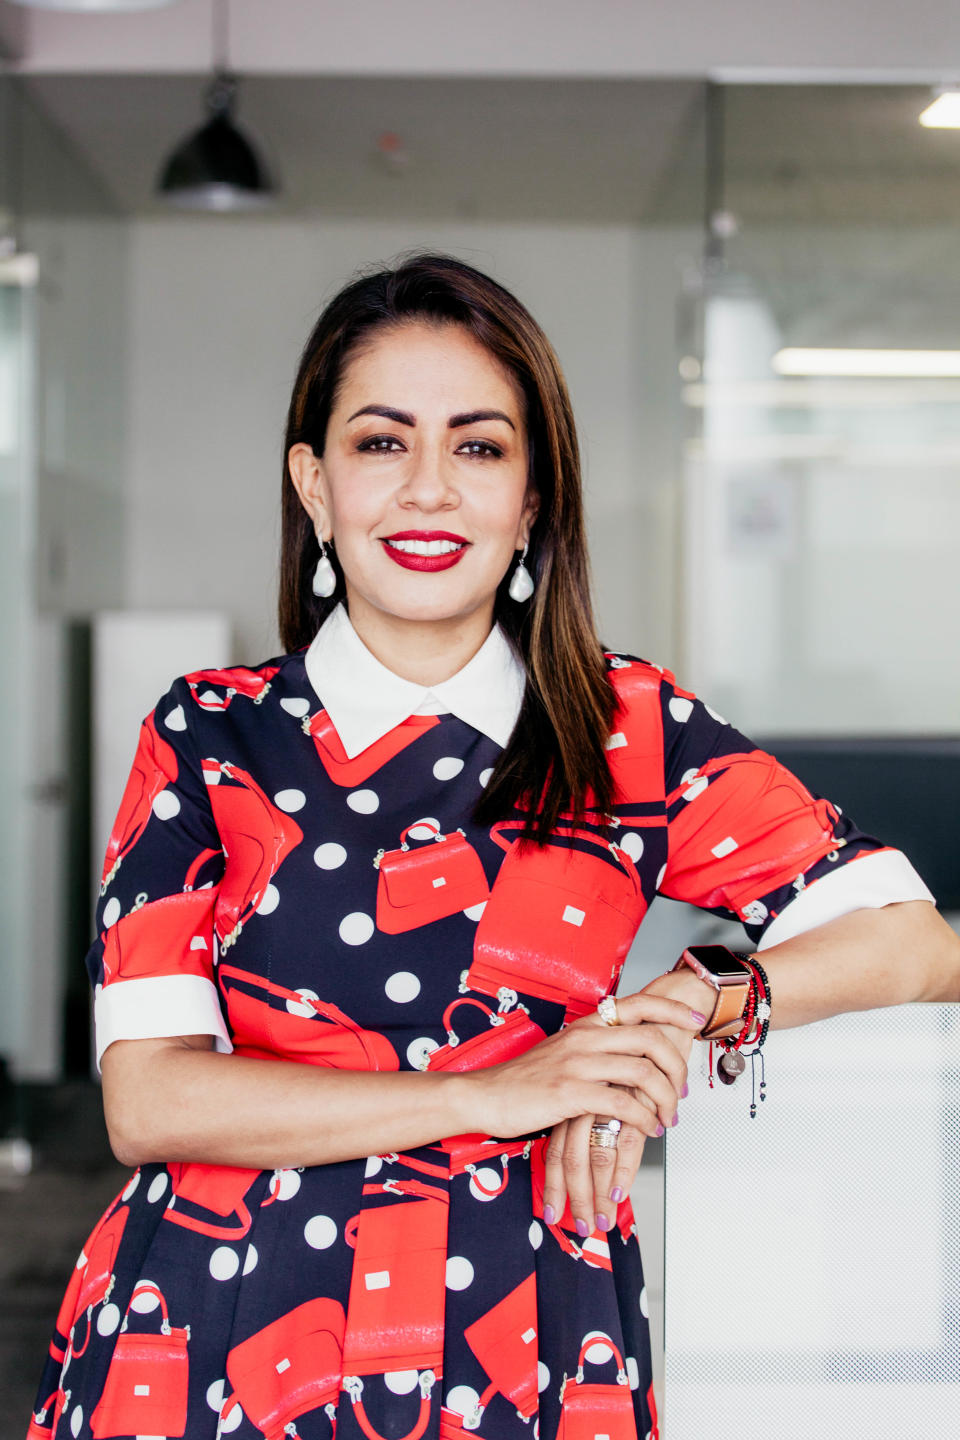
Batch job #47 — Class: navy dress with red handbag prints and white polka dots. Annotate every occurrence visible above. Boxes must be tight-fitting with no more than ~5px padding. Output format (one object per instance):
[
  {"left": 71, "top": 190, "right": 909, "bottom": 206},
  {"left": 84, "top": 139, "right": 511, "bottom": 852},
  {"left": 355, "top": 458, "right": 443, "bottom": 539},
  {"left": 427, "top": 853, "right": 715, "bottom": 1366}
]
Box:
[{"left": 30, "top": 652, "right": 903, "bottom": 1440}]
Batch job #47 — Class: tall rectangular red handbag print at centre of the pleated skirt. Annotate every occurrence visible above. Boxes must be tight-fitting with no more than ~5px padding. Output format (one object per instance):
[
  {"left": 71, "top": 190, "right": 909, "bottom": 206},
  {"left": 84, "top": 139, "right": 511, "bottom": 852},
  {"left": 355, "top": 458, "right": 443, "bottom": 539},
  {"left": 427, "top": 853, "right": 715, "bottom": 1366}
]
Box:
[{"left": 344, "top": 1179, "right": 449, "bottom": 1385}]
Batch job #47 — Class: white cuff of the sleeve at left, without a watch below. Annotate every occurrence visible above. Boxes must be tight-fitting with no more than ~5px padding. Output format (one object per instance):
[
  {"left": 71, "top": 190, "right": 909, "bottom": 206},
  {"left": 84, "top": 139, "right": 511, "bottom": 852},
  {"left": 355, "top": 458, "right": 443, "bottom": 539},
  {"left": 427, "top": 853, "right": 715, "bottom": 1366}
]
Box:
[{"left": 94, "top": 975, "right": 233, "bottom": 1070}]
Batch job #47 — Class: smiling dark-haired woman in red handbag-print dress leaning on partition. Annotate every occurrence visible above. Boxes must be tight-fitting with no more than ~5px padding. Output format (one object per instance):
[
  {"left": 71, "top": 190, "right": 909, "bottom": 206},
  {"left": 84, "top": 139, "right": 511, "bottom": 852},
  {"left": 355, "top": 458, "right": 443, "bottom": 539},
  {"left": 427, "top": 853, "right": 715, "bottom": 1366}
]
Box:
[{"left": 32, "top": 255, "right": 960, "bottom": 1440}]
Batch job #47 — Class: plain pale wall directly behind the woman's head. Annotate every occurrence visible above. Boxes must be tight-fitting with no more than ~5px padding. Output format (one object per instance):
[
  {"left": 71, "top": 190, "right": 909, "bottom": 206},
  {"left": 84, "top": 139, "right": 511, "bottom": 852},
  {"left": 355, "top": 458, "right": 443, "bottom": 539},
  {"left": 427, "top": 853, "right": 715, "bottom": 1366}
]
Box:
[{"left": 127, "top": 217, "right": 698, "bottom": 662}]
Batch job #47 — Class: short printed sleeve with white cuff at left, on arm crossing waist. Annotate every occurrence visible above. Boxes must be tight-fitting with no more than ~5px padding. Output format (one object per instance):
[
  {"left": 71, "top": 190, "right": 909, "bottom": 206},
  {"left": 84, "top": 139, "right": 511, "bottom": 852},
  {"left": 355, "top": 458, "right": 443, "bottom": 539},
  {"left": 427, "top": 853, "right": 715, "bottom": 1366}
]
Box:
[{"left": 86, "top": 680, "right": 232, "bottom": 1066}]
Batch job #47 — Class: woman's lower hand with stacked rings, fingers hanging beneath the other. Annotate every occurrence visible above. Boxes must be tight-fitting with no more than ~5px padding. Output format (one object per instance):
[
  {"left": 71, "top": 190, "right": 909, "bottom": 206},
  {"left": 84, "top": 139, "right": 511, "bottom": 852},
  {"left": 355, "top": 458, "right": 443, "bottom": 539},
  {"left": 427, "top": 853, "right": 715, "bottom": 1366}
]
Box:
[{"left": 544, "top": 971, "right": 714, "bottom": 1240}]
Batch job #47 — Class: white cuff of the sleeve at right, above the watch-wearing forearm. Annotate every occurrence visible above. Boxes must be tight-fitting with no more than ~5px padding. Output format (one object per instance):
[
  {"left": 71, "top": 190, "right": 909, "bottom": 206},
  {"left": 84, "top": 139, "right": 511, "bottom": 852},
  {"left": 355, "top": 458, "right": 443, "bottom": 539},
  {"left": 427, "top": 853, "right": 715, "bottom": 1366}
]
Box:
[{"left": 757, "top": 850, "right": 936, "bottom": 950}]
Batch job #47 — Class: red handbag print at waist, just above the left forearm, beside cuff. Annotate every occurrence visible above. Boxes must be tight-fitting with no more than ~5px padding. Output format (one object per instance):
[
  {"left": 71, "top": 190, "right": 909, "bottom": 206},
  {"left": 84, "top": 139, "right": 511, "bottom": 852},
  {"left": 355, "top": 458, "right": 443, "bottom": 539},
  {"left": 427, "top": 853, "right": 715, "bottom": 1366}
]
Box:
[{"left": 217, "top": 965, "right": 400, "bottom": 1070}]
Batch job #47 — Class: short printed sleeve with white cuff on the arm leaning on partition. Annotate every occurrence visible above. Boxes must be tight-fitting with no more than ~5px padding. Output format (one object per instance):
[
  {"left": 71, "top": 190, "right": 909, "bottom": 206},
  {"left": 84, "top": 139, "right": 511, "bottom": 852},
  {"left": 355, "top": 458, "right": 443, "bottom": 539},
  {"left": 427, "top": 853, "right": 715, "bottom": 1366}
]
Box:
[{"left": 658, "top": 672, "right": 933, "bottom": 949}]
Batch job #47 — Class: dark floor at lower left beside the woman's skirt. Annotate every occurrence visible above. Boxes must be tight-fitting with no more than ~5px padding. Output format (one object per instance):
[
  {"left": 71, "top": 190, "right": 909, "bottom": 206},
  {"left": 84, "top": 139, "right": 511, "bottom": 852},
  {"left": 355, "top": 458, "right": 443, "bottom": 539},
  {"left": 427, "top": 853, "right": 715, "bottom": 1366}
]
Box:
[{"left": 0, "top": 1081, "right": 128, "bottom": 1440}]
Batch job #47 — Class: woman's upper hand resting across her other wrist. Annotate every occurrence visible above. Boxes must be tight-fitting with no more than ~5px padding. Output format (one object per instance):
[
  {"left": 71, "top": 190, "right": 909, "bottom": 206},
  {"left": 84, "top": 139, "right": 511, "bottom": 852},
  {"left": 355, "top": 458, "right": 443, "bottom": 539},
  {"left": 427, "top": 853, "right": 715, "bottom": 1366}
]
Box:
[{"left": 465, "top": 991, "right": 705, "bottom": 1139}]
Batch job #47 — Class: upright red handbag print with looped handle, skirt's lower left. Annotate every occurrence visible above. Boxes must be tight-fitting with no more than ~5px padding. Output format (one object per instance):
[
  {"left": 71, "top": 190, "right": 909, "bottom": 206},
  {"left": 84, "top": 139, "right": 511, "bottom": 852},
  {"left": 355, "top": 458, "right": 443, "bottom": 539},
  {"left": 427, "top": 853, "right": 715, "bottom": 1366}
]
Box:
[{"left": 91, "top": 1282, "right": 190, "bottom": 1440}]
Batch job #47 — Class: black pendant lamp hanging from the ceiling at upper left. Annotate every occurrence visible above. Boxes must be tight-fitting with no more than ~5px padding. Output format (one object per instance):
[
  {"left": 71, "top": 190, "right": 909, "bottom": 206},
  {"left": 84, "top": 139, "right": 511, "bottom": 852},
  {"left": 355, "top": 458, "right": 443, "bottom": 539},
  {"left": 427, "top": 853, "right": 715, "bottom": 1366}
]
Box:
[{"left": 157, "top": 0, "right": 276, "bottom": 212}]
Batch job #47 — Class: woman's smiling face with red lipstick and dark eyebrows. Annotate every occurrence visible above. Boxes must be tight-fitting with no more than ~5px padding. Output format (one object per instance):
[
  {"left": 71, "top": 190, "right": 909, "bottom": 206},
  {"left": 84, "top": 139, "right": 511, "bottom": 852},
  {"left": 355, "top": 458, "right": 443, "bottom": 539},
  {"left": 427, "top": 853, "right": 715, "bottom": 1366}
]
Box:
[{"left": 289, "top": 323, "right": 537, "bottom": 628}]
